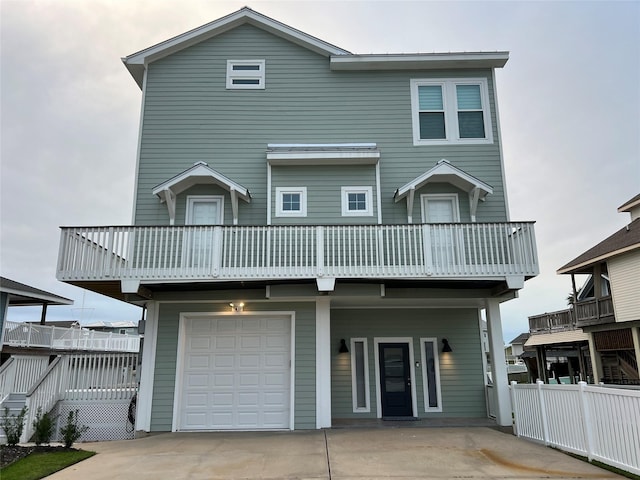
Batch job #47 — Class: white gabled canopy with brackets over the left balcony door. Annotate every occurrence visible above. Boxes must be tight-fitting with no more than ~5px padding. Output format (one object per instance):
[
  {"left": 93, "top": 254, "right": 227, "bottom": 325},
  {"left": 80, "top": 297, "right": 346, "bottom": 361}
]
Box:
[{"left": 153, "top": 162, "right": 251, "bottom": 225}]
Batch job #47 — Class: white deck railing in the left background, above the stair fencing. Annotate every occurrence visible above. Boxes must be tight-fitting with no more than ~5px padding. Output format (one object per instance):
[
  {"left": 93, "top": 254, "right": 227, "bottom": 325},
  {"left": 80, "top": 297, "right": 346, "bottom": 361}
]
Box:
[{"left": 4, "top": 321, "right": 140, "bottom": 352}]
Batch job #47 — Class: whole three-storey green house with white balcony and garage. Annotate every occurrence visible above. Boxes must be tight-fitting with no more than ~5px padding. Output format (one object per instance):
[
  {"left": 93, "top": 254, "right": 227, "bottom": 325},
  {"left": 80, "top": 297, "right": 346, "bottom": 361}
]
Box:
[{"left": 57, "top": 8, "right": 538, "bottom": 432}]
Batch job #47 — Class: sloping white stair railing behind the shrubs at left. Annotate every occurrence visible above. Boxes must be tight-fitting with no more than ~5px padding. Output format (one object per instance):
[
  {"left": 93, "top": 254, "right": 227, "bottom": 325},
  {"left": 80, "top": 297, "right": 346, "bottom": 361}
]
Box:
[{"left": 20, "top": 356, "right": 69, "bottom": 442}]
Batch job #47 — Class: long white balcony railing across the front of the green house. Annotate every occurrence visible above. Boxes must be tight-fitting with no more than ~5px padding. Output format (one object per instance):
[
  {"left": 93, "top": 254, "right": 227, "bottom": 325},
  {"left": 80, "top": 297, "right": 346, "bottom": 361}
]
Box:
[{"left": 57, "top": 222, "right": 538, "bottom": 283}]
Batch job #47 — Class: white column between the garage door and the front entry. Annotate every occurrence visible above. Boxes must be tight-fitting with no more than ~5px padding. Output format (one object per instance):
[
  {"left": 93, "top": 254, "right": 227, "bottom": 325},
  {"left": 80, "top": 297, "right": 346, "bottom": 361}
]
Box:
[{"left": 316, "top": 296, "right": 331, "bottom": 428}]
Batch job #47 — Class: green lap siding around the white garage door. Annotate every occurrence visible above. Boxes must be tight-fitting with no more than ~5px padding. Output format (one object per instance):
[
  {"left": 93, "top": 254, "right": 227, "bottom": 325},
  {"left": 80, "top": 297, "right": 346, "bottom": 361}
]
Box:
[{"left": 151, "top": 300, "right": 316, "bottom": 432}]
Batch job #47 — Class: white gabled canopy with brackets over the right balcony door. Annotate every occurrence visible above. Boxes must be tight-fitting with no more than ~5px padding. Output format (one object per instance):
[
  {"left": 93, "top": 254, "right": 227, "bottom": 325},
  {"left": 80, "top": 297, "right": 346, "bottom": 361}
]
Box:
[{"left": 393, "top": 158, "right": 493, "bottom": 223}]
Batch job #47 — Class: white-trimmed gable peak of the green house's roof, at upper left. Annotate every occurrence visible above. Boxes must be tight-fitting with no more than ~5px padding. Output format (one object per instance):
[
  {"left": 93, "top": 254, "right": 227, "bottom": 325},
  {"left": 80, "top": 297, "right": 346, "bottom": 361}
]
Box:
[{"left": 122, "top": 7, "right": 349, "bottom": 88}]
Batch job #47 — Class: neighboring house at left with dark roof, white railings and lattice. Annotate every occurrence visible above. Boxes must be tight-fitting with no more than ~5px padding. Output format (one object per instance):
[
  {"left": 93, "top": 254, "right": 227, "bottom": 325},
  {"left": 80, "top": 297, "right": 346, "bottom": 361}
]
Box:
[{"left": 0, "top": 278, "right": 140, "bottom": 443}]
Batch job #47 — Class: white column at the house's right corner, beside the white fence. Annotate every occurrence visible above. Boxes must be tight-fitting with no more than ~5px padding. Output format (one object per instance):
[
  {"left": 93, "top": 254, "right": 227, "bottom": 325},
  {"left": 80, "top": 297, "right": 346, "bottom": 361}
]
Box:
[{"left": 485, "top": 298, "right": 512, "bottom": 427}]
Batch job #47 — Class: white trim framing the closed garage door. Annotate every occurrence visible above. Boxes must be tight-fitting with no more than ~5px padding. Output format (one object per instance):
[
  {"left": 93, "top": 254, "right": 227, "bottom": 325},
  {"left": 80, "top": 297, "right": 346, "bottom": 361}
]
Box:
[{"left": 171, "top": 311, "right": 296, "bottom": 432}]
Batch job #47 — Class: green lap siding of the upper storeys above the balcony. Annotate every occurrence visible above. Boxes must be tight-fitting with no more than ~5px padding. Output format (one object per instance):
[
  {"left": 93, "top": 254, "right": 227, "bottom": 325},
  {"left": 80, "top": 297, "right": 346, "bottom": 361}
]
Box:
[{"left": 135, "top": 25, "right": 506, "bottom": 229}]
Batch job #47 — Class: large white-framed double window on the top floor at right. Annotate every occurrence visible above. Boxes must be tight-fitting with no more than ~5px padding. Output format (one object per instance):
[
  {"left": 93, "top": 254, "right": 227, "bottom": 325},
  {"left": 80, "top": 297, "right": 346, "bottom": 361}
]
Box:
[{"left": 411, "top": 78, "right": 493, "bottom": 145}]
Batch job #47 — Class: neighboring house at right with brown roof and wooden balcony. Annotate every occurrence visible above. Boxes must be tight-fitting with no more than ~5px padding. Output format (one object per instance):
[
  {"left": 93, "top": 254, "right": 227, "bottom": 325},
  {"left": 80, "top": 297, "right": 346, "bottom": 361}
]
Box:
[{"left": 526, "top": 195, "right": 640, "bottom": 384}]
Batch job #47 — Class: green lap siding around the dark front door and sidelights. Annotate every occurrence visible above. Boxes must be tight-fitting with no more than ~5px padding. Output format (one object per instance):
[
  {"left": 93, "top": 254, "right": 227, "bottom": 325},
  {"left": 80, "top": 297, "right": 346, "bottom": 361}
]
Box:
[{"left": 331, "top": 309, "right": 487, "bottom": 418}]
